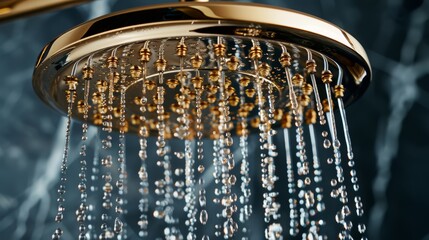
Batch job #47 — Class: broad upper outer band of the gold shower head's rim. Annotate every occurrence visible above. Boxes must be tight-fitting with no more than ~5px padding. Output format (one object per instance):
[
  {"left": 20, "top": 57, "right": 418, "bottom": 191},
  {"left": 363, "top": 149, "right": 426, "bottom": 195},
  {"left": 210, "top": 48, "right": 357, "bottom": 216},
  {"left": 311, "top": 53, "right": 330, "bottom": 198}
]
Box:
[{"left": 39, "top": 2, "right": 369, "bottom": 66}]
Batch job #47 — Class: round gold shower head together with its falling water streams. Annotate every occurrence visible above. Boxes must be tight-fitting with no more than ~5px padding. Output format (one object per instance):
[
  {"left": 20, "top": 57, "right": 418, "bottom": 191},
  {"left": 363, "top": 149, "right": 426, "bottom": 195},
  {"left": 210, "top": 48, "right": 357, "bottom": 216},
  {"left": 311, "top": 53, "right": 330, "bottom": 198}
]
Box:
[{"left": 33, "top": 1, "right": 371, "bottom": 239}]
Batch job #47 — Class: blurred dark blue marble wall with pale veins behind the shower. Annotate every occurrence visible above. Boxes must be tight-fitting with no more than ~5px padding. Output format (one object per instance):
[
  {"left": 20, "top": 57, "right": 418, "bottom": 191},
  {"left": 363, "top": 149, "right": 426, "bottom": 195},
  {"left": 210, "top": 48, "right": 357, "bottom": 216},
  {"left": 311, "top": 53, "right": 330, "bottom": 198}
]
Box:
[{"left": 0, "top": 0, "right": 429, "bottom": 240}]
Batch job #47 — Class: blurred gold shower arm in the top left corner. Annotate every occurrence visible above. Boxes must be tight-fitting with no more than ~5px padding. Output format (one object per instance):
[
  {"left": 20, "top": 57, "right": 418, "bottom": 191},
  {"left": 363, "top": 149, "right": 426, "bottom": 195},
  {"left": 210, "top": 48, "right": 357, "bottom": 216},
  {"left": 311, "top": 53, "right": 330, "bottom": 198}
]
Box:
[{"left": 0, "top": 0, "right": 90, "bottom": 22}]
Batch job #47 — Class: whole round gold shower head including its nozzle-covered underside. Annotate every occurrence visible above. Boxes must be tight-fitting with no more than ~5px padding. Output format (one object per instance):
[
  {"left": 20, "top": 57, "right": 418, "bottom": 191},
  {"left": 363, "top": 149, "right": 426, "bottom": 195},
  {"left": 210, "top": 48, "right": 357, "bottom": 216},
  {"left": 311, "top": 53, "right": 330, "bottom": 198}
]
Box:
[{"left": 33, "top": 2, "right": 371, "bottom": 137}]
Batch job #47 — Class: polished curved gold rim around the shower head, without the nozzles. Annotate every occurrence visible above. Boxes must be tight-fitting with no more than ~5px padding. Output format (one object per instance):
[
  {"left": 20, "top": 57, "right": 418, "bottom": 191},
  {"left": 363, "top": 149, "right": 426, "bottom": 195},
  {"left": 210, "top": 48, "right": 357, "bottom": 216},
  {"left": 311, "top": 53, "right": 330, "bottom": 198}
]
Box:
[{"left": 33, "top": 2, "right": 371, "bottom": 129}]
